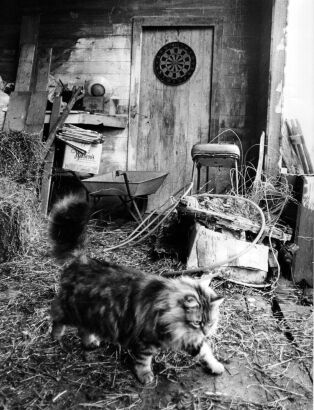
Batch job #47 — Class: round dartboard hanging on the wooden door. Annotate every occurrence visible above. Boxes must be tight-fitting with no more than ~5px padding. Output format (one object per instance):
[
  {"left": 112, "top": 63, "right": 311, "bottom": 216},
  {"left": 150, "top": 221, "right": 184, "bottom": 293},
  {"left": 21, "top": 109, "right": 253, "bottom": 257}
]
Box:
[{"left": 154, "top": 41, "right": 196, "bottom": 85}]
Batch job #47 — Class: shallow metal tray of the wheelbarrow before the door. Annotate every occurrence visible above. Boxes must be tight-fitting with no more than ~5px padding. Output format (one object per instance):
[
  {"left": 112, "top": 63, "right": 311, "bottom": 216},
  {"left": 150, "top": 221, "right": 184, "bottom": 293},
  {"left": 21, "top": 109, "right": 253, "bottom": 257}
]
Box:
[{"left": 81, "top": 171, "right": 168, "bottom": 197}]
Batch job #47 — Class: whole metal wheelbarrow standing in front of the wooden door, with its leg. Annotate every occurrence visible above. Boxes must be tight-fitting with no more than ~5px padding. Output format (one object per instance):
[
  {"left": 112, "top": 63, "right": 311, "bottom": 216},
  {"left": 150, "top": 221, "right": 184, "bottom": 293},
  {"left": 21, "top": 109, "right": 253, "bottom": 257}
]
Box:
[{"left": 81, "top": 170, "right": 168, "bottom": 222}]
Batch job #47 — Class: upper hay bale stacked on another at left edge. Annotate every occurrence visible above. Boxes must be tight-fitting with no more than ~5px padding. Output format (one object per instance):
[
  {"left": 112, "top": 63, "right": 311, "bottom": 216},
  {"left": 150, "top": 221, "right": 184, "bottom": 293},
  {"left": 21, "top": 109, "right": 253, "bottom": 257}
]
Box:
[{"left": 0, "top": 130, "right": 44, "bottom": 186}]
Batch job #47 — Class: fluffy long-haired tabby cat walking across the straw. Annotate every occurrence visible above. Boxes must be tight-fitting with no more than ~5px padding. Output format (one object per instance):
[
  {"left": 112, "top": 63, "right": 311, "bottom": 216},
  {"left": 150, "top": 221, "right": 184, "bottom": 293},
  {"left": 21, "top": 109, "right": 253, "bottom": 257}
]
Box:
[{"left": 49, "top": 196, "right": 224, "bottom": 384}]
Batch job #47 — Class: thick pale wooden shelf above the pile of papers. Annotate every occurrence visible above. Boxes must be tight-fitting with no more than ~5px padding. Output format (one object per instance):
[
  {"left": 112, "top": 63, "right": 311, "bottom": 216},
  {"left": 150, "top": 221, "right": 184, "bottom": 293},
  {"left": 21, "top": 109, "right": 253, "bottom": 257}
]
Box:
[{"left": 45, "top": 111, "right": 128, "bottom": 128}]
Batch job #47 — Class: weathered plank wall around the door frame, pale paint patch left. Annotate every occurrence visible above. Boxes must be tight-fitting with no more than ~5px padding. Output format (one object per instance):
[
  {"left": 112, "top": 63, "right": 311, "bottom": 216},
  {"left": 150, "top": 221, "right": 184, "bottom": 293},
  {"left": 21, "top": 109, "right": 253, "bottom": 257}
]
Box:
[{"left": 0, "top": 0, "right": 270, "bottom": 171}]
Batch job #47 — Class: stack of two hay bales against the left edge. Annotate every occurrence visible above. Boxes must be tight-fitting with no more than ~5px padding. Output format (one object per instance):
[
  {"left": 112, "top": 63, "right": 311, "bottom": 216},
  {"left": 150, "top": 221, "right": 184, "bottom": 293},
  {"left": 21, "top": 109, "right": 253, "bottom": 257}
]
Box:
[{"left": 0, "top": 131, "right": 44, "bottom": 263}]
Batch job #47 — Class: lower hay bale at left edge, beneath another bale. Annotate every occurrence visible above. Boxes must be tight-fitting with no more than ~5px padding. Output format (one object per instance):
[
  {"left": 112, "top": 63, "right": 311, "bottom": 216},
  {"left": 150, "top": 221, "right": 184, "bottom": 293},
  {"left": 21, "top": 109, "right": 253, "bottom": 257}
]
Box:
[{"left": 0, "top": 177, "right": 41, "bottom": 263}]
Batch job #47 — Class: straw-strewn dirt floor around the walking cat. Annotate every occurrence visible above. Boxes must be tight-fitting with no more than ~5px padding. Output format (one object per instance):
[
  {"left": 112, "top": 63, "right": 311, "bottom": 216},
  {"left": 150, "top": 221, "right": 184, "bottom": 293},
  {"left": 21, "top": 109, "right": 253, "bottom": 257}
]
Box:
[{"left": 0, "top": 218, "right": 313, "bottom": 410}]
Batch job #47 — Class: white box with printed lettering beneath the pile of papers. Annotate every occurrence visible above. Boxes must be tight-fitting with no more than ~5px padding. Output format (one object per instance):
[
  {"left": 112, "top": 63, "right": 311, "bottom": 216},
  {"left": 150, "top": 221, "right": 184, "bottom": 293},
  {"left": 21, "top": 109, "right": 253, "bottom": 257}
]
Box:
[{"left": 62, "top": 144, "right": 102, "bottom": 174}]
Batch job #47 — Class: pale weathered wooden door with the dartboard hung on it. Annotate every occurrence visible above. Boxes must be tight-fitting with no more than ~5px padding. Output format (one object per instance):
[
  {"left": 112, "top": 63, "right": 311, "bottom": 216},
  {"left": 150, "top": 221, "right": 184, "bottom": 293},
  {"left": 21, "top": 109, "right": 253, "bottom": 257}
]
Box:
[{"left": 130, "top": 27, "right": 213, "bottom": 211}]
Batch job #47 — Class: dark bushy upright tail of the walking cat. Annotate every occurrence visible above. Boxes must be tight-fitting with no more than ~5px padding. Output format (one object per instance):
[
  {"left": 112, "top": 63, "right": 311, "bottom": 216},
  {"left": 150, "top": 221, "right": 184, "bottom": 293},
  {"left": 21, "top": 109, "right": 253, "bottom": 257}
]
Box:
[{"left": 49, "top": 195, "right": 90, "bottom": 262}]
